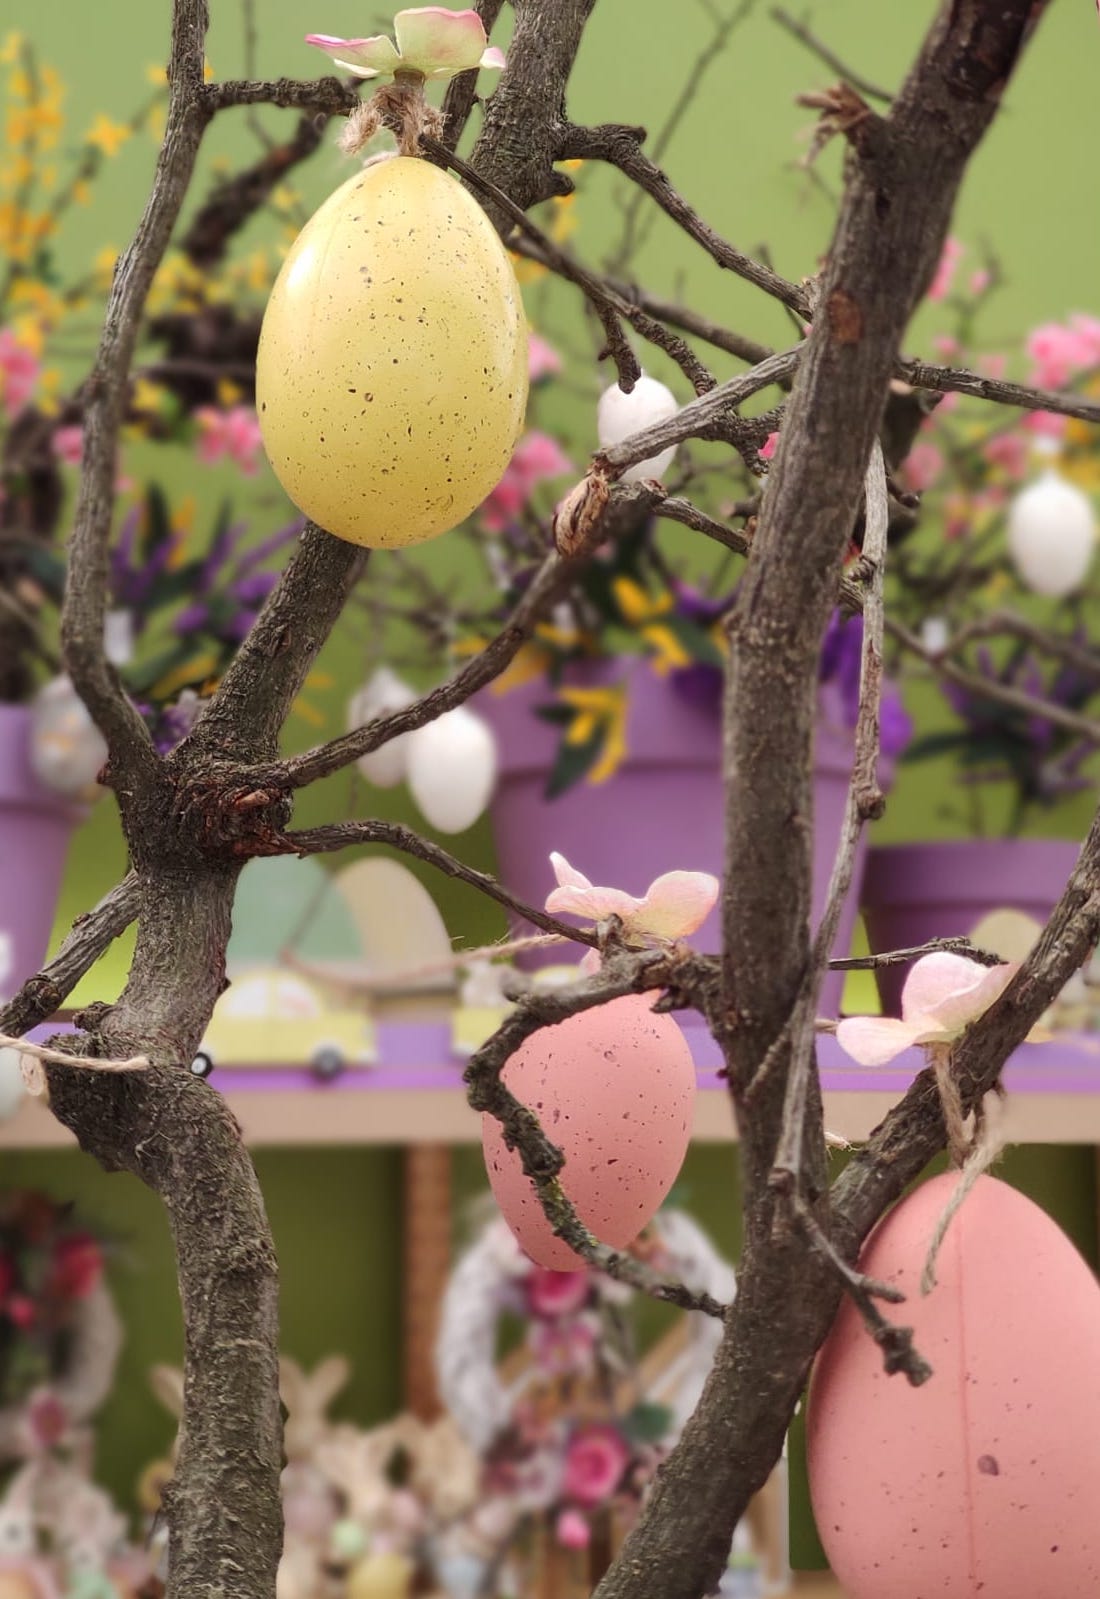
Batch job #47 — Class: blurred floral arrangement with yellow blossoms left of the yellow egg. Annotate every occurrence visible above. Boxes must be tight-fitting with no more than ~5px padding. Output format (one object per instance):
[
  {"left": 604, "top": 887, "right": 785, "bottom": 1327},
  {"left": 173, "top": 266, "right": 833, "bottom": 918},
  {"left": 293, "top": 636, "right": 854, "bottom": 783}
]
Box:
[{"left": 0, "top": 34, "right": 320, "bottom": 796}]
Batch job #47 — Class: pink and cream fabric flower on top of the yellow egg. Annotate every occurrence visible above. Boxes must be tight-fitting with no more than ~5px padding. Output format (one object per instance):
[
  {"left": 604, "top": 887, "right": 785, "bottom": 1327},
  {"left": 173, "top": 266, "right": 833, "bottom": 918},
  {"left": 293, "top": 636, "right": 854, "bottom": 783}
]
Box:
[{"left": 305, "top": 5, "right": 504, "bottom": 78}]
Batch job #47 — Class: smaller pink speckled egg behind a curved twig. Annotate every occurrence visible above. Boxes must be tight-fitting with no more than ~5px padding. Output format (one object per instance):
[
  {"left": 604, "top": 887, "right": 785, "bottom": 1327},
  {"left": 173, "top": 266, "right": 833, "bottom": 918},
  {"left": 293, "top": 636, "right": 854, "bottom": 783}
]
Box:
[{"left": 481, "top": 995, "right": 695, "bottom": 1271}]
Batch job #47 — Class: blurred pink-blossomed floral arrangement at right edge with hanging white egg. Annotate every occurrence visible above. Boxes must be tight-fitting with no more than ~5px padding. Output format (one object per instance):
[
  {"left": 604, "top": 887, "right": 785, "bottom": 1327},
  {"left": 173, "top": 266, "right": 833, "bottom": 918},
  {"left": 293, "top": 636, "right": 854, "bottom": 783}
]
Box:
[{"left": 891, "top": 240, "right": 1100, "bottom": 833}]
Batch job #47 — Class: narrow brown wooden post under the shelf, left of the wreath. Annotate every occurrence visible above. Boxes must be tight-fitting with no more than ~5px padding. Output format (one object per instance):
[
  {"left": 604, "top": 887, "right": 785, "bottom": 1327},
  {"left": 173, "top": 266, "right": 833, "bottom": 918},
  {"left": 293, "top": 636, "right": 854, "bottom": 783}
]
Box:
[{"left": 401, "top": 1143, "right": 451, "bottom": 1422}]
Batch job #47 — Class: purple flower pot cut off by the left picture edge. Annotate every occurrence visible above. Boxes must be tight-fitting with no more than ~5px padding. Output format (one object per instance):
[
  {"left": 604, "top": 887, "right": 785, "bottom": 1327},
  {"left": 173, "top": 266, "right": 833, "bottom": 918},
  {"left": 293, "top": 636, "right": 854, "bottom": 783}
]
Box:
[{"left": 0, "top": 705, "right": 83, "bottom": 998}]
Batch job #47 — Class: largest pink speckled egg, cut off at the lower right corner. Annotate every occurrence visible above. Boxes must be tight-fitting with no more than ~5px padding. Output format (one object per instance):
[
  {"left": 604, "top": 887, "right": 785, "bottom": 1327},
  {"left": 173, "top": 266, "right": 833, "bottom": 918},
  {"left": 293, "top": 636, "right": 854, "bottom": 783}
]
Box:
[{"left": 807, "top": 1174, "right": 1100, "bottom": 1599}]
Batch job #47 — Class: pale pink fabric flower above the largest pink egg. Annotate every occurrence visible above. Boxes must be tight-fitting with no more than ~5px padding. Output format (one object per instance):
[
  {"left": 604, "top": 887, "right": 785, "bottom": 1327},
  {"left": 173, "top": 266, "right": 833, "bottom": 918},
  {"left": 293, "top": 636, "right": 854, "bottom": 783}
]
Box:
[{"left": 836, "top": 950, "right": 1020, "bottom": 1067}]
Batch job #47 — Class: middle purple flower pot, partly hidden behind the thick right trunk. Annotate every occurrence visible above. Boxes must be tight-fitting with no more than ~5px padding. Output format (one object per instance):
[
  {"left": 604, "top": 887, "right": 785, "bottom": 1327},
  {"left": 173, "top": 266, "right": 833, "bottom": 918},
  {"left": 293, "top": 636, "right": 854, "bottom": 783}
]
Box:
[{"left": 478, "top": 660, "right": 862, "bottom": 1015}]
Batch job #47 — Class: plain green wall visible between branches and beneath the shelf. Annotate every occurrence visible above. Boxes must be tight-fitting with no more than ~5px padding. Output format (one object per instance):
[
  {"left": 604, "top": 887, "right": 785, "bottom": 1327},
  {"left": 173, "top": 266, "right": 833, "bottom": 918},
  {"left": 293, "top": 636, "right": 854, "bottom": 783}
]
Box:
[{"left": 8, "top": 0, "right": 1100, "bottom": 1557}]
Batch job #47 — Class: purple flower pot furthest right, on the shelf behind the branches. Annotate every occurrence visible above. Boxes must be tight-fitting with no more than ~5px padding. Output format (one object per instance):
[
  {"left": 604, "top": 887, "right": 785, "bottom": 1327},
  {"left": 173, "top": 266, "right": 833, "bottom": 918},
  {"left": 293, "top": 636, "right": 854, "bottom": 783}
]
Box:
[{"left": 863, "top": 838, "right": 1081, "bottom": 1015}]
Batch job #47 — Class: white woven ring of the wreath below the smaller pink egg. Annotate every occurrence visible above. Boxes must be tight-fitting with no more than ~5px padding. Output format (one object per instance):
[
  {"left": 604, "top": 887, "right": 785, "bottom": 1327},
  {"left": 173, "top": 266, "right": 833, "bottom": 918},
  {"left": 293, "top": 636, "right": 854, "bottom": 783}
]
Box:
[{"left": 436, "top": 1209, "right": 737, "bottom": 1455}]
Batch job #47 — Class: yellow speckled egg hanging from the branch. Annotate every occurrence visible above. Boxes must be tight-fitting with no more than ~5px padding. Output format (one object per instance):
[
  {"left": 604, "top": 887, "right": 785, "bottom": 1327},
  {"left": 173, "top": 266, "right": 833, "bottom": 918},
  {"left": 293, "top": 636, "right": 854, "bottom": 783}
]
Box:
[{"left": 256, "top": 157, "right": 528, "bottom": 548}]
